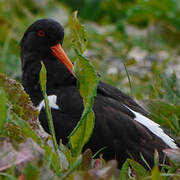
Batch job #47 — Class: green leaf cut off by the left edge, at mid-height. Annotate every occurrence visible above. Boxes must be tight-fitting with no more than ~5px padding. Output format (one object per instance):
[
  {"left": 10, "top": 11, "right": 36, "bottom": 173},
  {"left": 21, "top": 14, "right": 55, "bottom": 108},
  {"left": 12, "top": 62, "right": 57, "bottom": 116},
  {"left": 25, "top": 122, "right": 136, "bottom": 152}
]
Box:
[{"left": 0, "top": 87, "right": 7, "bottom": 134}]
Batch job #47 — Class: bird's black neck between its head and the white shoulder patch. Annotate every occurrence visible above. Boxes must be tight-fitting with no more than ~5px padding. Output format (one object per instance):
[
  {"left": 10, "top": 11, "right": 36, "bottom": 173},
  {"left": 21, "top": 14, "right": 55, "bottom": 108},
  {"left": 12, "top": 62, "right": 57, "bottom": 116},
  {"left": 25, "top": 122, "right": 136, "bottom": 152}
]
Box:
[{"left": 21, "top": 51, "right": 76, "bottom": 106}]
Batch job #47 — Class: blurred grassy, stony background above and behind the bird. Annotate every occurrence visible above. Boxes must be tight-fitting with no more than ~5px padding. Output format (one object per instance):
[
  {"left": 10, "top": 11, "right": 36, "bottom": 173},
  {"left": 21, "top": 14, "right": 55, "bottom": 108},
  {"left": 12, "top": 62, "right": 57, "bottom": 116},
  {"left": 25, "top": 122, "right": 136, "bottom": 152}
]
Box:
[{"left": 0, "top": 0, "right": 180, "bottom": 104}]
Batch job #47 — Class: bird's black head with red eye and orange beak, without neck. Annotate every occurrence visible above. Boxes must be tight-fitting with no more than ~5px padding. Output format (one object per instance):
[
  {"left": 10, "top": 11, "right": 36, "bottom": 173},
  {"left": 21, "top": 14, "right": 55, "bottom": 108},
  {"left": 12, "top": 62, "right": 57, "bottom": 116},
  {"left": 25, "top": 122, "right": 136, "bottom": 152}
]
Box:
[{"left": 20, "top": 19, "right": 74, "bottom": 75}]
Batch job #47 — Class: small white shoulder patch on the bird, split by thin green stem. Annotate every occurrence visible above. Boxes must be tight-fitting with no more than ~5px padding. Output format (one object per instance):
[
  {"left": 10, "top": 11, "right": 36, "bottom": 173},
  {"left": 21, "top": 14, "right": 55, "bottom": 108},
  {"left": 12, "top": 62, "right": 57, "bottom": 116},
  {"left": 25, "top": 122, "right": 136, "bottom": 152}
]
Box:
[{"left": 37, "top": 95, "right": 60, "bottom": 112}]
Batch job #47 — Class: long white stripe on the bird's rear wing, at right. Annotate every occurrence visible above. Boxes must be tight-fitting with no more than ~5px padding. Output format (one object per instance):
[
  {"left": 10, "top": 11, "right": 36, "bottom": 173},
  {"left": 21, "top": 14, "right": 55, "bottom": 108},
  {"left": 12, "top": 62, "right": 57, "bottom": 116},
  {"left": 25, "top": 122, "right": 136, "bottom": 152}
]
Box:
[{"left": 124, "top": 105, "right": 178, "bottom": 149}]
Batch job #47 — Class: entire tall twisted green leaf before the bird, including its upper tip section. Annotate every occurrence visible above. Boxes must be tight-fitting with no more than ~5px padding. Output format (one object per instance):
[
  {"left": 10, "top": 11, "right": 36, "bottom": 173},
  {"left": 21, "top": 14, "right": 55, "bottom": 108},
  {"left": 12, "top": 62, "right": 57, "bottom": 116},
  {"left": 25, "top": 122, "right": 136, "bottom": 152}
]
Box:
[{"left": 69, "top": 12, "right": 98, "bottom": 156}]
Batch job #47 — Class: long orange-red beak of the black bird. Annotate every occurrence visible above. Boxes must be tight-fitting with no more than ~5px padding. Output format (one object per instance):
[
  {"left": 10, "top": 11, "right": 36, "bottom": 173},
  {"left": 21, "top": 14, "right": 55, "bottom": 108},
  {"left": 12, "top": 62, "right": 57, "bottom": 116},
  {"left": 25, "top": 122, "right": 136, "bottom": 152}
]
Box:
[{"left": 51, "top": 44, "right": 76, "bottom": 77}]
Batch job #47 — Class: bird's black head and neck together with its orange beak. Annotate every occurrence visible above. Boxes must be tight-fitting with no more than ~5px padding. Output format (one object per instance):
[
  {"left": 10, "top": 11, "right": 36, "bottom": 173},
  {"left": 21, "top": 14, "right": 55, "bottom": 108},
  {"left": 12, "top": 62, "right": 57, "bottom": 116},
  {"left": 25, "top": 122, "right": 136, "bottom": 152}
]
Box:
[{"left": 21, "top": 19, "right": 76, "bottom": 105}]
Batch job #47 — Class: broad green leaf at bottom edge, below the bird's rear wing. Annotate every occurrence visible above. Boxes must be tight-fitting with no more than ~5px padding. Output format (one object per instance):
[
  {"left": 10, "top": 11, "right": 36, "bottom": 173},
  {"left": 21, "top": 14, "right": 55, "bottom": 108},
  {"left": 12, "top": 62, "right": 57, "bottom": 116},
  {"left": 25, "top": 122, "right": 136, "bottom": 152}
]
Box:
[{"left": 128, "top": 159, "right": 149, "bottom": 179}]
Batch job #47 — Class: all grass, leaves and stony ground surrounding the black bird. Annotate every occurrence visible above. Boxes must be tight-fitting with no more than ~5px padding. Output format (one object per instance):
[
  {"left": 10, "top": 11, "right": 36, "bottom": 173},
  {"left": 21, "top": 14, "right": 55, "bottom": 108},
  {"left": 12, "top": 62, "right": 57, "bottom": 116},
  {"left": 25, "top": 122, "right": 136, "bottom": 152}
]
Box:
[{"left": 0, "top": 0, "right": 180, "bottom": 180}]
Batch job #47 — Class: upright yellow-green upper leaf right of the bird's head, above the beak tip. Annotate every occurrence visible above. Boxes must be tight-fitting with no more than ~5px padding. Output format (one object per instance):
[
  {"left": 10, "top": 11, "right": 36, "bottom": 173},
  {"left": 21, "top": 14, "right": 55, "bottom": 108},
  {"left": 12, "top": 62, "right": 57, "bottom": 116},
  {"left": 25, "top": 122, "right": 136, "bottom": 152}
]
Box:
[{"left": 70, "top": 11, "right": 88, "bottom": 54}]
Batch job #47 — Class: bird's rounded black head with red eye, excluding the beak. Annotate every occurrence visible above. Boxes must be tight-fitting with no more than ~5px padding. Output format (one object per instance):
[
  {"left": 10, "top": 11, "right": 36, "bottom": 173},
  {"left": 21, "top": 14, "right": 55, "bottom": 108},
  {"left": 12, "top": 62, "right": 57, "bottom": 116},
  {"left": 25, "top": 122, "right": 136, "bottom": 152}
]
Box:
[{"left": 20, "top": 19, "right": 64, "bottom": 52}]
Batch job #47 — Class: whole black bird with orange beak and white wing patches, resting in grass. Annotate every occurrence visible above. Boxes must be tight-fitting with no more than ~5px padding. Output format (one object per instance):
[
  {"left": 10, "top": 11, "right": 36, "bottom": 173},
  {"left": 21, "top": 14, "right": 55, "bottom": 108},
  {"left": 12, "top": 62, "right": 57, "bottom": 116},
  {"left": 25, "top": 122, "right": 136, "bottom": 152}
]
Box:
[{"left": 20, "top": 18, "right": 178, "bottom": 167}]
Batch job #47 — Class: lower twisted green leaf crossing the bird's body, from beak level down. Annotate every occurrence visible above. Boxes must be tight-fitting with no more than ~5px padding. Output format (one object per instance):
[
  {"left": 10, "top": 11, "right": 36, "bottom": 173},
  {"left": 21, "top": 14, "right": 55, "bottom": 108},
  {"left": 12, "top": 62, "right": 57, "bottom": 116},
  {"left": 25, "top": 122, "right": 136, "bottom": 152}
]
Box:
[{"left": 69, "top": 49, "right": 98, "bottom": 155}]
